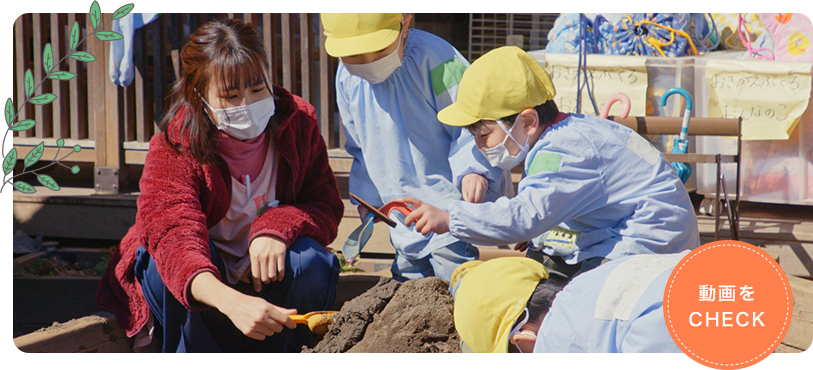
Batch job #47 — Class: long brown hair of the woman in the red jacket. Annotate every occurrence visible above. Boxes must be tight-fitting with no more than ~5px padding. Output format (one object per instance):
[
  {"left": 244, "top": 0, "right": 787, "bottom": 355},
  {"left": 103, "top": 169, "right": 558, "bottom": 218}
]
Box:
[{"left": 159, "top": 19, "right": 279, "bottom": 164}]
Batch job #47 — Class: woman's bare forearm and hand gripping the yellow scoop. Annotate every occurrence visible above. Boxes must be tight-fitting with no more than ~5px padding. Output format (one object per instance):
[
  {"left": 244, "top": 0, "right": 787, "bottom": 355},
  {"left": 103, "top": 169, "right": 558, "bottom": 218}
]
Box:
[{"left": 190, "top": 272, "right": 297, "bottom": 340}]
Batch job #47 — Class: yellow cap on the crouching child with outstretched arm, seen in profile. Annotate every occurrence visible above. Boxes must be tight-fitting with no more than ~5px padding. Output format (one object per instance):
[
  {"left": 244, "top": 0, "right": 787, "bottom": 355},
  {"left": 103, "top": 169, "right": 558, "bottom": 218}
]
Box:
[{"left": 438, "top": 46, "right": 556, "bottom": 126}]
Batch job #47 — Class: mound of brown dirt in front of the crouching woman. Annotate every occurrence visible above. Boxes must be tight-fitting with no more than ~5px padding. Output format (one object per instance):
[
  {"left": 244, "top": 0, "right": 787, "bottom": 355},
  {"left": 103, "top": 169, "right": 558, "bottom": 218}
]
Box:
[{"left": 302, "top": 278, "right": 460, "bottom": 354}]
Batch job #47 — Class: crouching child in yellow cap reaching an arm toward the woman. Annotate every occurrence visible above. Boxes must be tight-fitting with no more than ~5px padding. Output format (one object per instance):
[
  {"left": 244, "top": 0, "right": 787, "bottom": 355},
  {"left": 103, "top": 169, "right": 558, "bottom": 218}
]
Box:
[{"left": 401, "top": 47, "right": 700, "bottom": 278}]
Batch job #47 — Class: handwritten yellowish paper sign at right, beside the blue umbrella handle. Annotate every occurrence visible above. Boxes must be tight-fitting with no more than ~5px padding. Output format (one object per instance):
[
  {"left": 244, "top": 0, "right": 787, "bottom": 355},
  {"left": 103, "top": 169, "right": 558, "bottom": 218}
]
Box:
[{"left": 706, "top": 60, "right": 813, "bottom": 140}]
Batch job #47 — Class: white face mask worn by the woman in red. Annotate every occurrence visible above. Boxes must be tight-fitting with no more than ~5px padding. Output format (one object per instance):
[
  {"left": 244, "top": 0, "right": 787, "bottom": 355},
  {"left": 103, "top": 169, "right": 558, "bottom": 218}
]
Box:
[{"left": 201, "top": 96, "right": 276, "bottom": 140}]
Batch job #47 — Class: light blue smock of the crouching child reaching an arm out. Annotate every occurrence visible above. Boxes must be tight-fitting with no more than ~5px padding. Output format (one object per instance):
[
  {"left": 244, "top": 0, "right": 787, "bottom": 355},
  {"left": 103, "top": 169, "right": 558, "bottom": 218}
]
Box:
[{"left": 447, "top": 114, "right": 700, "bottom": 264}]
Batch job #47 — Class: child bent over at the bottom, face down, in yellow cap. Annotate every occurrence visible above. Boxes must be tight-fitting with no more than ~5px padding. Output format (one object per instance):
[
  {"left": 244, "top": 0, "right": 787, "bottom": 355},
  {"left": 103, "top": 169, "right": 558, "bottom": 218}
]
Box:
[{"left": 452, "top": 251, "right": 688, "bottom": 354}]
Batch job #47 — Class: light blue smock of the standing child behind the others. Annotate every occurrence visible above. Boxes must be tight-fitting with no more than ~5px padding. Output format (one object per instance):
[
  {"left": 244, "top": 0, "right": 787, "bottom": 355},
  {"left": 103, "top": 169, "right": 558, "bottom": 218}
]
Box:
[{"left": 336, "top": 29, "right": 513, "bottom": 259}]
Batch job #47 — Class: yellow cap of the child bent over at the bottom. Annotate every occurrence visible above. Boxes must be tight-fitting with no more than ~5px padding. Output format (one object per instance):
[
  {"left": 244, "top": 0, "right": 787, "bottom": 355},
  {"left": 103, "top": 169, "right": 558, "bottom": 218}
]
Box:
[{"left": 454, "top": 257, "right": 548, "bottom": 354}]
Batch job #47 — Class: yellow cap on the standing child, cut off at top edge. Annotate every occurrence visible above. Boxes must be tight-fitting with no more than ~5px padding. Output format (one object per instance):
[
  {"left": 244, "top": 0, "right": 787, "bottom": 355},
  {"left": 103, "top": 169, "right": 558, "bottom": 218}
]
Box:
[{"left": 319, "top": 11, "right": 404, "bottom": 58}]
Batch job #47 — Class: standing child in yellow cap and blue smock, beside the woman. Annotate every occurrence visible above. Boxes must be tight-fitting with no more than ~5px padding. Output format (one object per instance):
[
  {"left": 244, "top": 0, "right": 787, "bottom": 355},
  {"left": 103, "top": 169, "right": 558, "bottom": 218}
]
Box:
[{"left": 320, "top": 11, "right": 513, "bottom": 281}]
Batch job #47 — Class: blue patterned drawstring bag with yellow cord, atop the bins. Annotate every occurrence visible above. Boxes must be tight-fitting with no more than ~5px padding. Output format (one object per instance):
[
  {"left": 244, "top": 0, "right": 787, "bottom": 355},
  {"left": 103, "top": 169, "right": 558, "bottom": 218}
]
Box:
[{"left": 609, "top": 11, "right": 698, "bottom": 58}]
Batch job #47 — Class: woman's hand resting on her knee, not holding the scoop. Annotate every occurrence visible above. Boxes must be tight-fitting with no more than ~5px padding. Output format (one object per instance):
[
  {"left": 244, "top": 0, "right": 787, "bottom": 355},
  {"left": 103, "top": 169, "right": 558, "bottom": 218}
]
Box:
[{"left": 248, "top": 236, "right": 288, "bottom": 292}]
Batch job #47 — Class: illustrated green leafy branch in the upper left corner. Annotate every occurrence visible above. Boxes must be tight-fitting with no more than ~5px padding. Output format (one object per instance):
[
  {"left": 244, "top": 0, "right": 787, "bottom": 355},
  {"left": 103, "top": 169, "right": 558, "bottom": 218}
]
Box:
[{"left": 0, "top": 1, "right": 135, "bottom": 194}]
